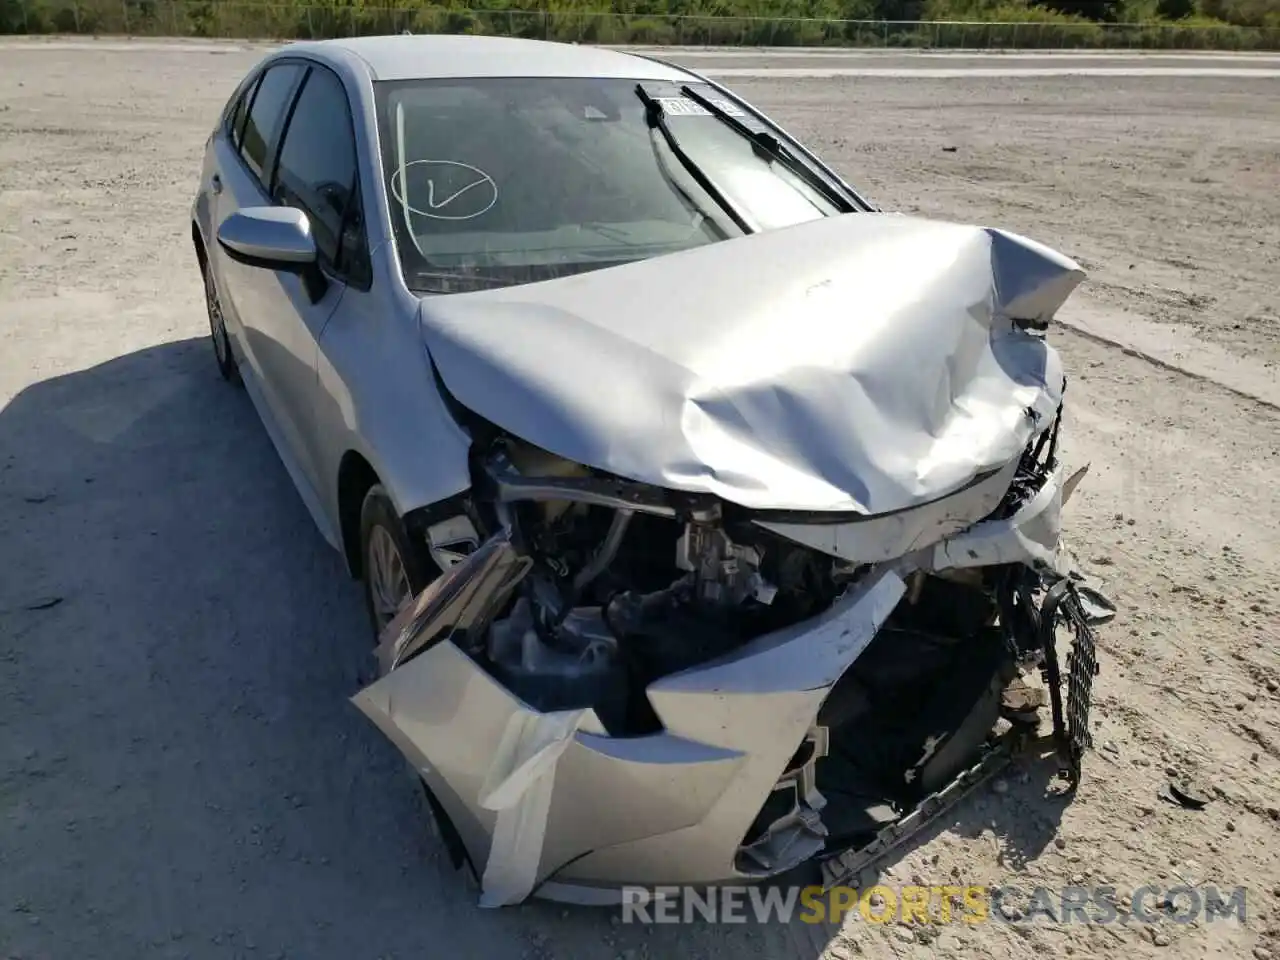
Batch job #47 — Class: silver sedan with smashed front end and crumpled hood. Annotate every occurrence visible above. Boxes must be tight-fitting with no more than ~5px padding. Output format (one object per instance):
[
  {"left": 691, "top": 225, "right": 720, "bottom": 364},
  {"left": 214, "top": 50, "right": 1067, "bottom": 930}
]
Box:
[{"left": 192, "top": 36, "right": 1111, "bottom": 906}]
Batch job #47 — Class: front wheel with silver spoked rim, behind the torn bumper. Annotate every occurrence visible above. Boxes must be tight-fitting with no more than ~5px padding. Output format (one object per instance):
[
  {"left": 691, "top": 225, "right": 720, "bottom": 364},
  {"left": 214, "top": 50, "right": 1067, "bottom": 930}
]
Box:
[{"left": 360, "top": 484, "right": 439, "bottom": 643}]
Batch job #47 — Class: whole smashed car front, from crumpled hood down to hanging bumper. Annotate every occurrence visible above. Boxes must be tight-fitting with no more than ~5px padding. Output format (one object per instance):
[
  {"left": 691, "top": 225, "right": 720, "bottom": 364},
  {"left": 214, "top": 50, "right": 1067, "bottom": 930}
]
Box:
[{"left": 353, "top": 209, "right": 1114, "bottom": 906}]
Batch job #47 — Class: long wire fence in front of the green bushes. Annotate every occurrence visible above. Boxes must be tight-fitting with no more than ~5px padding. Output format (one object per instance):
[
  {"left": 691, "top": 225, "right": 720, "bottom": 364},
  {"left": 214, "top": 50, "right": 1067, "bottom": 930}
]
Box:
[{"left": 0, "top": 0, "right": 1280, "bottom": 50}]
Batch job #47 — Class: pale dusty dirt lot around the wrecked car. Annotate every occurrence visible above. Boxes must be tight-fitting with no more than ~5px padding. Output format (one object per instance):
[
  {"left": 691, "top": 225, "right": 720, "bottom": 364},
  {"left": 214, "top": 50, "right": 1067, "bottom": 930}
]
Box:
[{"left": 0, "top": 37, "right": 1280, "bottom": 960}]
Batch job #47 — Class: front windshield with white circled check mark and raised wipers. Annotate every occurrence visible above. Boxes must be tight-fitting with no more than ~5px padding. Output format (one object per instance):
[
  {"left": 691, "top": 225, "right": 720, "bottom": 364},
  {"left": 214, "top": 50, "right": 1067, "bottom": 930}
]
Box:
[{"left": 376, "top": 78, "right": 852, "bottom": 293}]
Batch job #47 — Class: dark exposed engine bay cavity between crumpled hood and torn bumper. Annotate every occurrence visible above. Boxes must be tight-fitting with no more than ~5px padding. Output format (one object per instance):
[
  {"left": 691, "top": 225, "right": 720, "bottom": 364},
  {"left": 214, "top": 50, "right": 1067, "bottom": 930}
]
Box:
[{"left": 472, "top": 443, "right": 855, "bottom": 736}]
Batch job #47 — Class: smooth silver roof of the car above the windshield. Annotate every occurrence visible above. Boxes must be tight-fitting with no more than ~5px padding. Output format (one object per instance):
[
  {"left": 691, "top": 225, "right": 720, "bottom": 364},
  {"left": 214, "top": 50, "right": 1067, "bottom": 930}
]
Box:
[{"left": 280, "top": 33, "right": 691, "bottom": 82}]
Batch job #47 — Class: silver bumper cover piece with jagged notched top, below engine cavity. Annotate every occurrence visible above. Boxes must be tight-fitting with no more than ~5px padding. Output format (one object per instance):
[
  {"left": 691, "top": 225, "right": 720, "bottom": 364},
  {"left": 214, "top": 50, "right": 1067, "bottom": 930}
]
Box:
[{"left": 355, "top": 563, "right": 905, "bottom": 905}]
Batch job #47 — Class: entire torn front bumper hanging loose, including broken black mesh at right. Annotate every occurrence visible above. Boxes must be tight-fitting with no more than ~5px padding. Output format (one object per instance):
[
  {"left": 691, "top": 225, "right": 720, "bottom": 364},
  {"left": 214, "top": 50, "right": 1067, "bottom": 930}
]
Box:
[{"left": 353, "top": 422, "right": 1107, "bottom": 906}]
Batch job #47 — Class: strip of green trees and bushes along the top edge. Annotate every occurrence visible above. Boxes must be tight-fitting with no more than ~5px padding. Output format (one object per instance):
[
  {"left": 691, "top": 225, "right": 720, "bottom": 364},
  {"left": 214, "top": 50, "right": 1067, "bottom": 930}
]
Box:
[{"left": 0, "top": 0, "right": 1280, "bottom": 50}]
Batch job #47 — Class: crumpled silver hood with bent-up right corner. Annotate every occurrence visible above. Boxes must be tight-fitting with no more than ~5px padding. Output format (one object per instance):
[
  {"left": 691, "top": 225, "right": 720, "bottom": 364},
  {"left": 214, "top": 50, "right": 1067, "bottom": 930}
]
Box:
[{"left": 421, "top": 214, "right": 1084, "bottom": 513}]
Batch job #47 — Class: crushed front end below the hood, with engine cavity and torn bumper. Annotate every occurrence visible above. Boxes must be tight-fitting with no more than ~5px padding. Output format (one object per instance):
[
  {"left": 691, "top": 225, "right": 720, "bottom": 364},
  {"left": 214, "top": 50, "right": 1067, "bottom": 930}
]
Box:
[{"left": 355, "top": 407, "right": 1110, "bottom": 905}]
